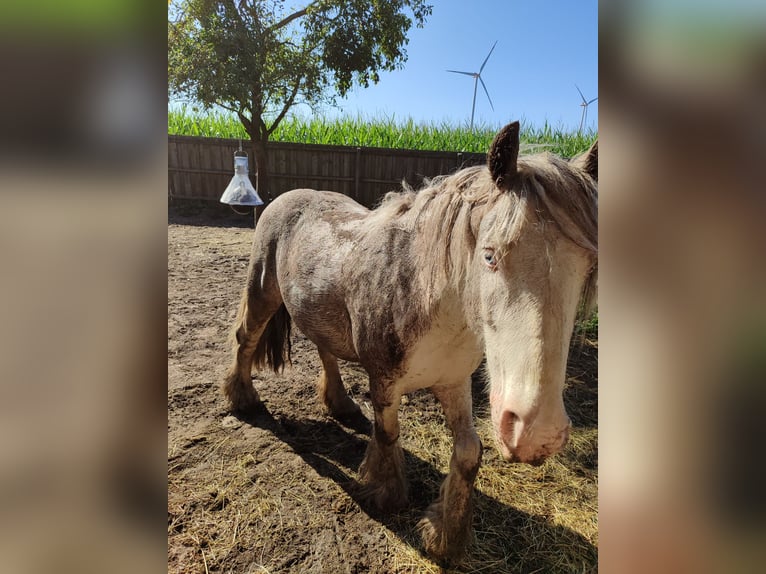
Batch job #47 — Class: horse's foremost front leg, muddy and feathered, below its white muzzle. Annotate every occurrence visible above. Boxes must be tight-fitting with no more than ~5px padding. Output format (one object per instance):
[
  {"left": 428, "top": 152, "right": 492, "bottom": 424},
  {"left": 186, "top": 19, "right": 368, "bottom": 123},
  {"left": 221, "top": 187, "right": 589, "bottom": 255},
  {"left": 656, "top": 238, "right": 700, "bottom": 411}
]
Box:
[{"left": 419, "top": 380, "right": 482, "bottom": 563}]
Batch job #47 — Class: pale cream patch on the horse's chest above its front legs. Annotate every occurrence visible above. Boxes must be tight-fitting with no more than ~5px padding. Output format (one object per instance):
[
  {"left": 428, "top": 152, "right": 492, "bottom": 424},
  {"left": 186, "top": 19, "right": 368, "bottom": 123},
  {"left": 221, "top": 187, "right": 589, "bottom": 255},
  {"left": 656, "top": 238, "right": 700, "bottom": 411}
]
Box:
[{"left": 399, "top": 329, "right": 484, "bottom": 393}]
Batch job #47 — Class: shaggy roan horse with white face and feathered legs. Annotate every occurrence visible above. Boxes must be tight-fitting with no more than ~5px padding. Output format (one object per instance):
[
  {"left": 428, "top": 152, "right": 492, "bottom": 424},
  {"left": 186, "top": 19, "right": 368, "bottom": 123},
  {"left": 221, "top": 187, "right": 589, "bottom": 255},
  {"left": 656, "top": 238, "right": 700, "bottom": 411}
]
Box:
[{"left": 223, "top": 122, "right": 598, "bottom": 563}]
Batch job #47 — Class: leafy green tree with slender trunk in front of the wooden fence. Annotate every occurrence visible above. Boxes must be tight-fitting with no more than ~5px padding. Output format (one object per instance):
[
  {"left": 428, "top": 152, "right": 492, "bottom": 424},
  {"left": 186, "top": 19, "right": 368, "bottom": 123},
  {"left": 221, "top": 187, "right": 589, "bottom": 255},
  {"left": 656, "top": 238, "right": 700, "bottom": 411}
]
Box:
[{"left": 168, "top": 0, "right": 432, "bottom": 199}]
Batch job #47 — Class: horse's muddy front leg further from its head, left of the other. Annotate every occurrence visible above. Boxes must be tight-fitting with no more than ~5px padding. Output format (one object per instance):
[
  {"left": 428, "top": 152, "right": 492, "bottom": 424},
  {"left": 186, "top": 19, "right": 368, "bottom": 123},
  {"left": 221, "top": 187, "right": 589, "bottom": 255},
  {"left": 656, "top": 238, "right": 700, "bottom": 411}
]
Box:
[{"left": 359, "top": 380, "right": 407, "bottom": 512}]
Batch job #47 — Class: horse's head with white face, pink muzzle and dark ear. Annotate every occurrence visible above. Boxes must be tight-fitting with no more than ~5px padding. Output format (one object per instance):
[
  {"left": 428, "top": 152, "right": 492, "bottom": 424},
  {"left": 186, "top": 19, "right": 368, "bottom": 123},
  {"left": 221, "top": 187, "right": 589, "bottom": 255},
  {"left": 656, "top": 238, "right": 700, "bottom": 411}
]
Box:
[{"left": 480, "top": 122, "right": 598, "bottom": 464}]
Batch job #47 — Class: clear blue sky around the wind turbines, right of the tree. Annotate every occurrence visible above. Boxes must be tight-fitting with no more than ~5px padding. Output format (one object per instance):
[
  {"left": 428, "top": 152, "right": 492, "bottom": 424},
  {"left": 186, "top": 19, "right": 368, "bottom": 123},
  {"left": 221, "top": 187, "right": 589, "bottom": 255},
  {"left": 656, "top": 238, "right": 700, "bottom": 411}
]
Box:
[{"left": 327, "top": 0, "right": 598, "bottom": 130}]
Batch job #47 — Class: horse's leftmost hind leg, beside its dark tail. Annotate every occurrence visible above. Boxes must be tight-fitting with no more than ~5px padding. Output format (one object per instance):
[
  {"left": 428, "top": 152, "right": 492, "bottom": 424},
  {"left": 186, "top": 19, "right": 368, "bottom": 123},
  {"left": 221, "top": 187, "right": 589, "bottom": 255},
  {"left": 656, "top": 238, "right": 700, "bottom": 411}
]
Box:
[{"left": 223, "top": 261, "right": 282, "bottom": 412}]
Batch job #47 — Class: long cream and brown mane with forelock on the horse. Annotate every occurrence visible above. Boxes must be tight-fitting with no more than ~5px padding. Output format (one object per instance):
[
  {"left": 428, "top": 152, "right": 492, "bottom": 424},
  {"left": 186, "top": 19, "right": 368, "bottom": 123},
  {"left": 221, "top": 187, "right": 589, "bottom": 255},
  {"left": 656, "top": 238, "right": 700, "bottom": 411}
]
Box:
[{"left": 370, "top": 153, "right": 598, "bottom": 320}]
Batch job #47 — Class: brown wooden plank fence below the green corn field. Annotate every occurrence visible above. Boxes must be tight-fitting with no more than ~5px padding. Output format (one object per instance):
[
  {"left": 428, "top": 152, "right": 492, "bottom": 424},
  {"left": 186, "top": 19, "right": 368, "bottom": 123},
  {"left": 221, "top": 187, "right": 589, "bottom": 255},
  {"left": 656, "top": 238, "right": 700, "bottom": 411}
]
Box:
[{"left": 168, "top": 135, "right": 486, "bottom": 207}]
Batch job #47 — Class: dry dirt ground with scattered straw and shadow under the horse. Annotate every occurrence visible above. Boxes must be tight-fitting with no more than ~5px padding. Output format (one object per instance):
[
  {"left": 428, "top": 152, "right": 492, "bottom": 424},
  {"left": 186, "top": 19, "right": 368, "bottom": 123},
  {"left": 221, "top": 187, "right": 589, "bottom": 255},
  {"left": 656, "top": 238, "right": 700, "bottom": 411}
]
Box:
[{"left": 168, "top": 204, "right": 598, "bottom": 573}]
